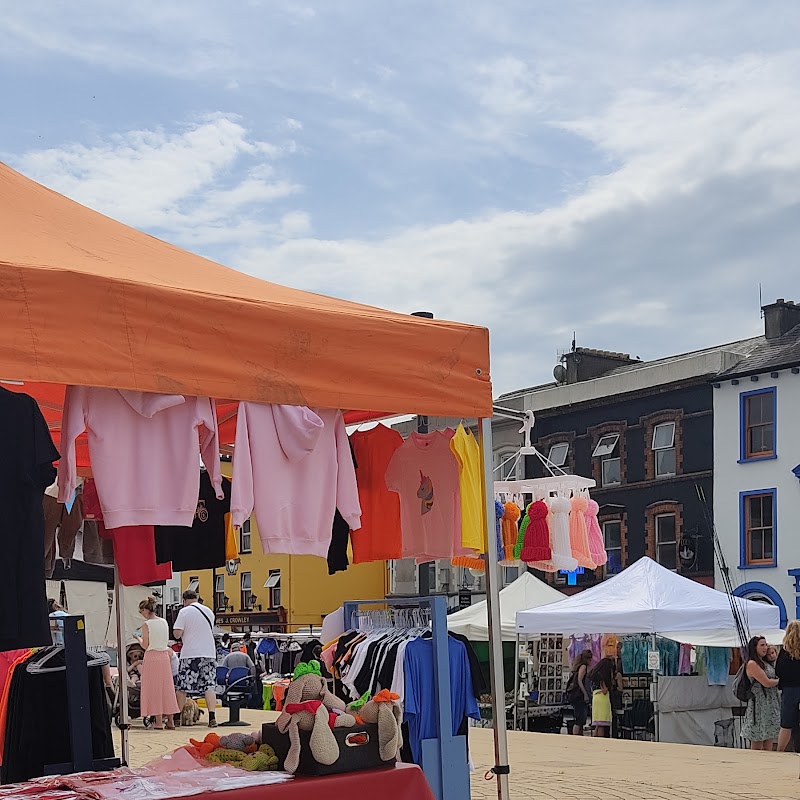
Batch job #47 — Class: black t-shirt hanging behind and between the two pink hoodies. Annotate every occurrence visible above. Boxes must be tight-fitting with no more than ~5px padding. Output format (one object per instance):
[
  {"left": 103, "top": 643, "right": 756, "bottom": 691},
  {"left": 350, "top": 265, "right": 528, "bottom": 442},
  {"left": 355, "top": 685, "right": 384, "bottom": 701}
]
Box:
[{"left": 155, "top": 470, "right": 231, "bottom": 572}]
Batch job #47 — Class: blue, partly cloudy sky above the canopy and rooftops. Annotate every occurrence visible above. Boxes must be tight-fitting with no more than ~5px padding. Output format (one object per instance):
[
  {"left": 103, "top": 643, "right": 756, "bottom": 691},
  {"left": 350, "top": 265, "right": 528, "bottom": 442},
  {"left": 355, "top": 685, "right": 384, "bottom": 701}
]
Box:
[{"left": 0, "top": 0, "right": 800, "bottom": 392}]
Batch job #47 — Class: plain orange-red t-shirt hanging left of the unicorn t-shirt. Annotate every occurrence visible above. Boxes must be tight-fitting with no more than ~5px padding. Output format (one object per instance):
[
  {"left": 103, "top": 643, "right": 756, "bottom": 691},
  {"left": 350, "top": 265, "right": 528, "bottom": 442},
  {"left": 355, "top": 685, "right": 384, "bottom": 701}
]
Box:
[{"left": 350, "top": 425, "right": 403, "bottom": 564}]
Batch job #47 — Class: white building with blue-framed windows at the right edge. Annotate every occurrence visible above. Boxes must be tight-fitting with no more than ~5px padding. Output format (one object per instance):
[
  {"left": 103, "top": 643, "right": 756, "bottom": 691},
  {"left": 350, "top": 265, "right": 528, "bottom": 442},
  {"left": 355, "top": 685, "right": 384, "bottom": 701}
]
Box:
[{"left": 714, "top": 300, "right": 800, "bottom": 633}]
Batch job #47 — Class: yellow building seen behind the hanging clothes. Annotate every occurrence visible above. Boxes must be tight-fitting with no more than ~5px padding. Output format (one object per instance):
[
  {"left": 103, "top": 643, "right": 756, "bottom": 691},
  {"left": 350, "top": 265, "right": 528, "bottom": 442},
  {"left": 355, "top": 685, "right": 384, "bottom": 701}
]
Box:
[{"left": 188, "top": 463, "right": 388, "bottom": 632}]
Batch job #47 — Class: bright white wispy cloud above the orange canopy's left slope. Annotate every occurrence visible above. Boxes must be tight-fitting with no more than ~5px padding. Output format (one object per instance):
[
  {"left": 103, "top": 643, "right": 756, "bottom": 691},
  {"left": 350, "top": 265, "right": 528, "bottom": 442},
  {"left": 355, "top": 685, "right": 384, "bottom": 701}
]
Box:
[{"left": 17, "top": 114, "right": 302, "bottom": 246}]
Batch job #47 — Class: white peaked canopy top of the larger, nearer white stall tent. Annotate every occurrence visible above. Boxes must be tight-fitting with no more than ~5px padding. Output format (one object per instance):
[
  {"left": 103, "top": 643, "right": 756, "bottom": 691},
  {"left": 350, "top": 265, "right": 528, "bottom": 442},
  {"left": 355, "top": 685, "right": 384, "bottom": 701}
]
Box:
[{"left": 516, "top": 557, "right": 782, "bottom": 646}]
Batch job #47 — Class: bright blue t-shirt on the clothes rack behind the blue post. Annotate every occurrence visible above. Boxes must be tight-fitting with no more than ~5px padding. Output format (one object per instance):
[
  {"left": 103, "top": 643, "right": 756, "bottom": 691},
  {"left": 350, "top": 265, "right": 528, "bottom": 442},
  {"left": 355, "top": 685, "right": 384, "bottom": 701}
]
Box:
[{"left": 403, "top": 636, "right": 480, "bottom": 764}]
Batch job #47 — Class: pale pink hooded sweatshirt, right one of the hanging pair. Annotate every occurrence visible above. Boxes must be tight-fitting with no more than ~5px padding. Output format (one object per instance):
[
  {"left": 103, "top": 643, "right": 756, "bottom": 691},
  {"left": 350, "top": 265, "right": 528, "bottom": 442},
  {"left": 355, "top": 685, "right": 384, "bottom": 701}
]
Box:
[{"left": 231, "top": 403, "right": 361, "bottom": 558}]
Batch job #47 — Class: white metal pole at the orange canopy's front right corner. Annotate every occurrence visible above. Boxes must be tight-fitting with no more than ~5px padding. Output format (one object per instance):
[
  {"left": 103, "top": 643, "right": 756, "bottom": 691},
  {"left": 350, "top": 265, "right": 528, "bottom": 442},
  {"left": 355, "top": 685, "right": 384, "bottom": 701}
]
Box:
[{"left": 478, "top": 418, "right": 510, "bottom": 800}]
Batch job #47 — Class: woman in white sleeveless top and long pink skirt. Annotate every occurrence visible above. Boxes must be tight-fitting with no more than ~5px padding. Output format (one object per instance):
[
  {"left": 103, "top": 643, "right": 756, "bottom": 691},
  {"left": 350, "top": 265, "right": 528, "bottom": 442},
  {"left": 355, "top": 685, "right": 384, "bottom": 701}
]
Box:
[{"left": 139, "top": 597, "right": 179, "bottom": 730}]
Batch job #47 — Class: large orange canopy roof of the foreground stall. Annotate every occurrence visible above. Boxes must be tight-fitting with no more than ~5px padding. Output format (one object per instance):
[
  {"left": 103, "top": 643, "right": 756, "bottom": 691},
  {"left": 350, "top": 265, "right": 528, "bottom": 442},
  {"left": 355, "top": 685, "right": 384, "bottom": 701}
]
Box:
[{"left": 0, "top": 163, "right": 492, "bottom": 444}]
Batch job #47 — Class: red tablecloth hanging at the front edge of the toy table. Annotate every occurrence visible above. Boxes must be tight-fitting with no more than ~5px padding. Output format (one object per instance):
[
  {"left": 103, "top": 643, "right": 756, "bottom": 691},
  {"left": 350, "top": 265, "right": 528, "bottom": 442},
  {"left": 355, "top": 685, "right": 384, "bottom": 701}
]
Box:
[{"left": 188, "top": 764, "right": 434, "bottom": 800}]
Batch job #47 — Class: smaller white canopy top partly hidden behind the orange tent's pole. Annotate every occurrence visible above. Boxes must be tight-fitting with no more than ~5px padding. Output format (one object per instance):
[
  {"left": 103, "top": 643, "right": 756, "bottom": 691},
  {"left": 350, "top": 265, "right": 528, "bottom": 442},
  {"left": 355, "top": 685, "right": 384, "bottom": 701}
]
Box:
[{"left": 447, "top": 572, "right": 566, "bottom": 642}]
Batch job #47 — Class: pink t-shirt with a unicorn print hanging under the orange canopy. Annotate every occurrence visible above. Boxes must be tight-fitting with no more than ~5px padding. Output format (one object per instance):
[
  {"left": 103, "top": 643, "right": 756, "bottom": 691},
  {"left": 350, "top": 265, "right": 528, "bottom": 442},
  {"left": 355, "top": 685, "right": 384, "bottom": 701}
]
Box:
[{"left": 386, "top": 431, "right": 472, "bottom": 563}]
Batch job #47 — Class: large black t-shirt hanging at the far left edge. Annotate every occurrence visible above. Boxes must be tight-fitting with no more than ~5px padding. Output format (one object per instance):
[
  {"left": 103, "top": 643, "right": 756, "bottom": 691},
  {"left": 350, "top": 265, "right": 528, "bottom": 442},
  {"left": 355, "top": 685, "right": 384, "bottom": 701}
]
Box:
[{"left": 0, "top": 388, "right": 60, "bottom": 651}]
